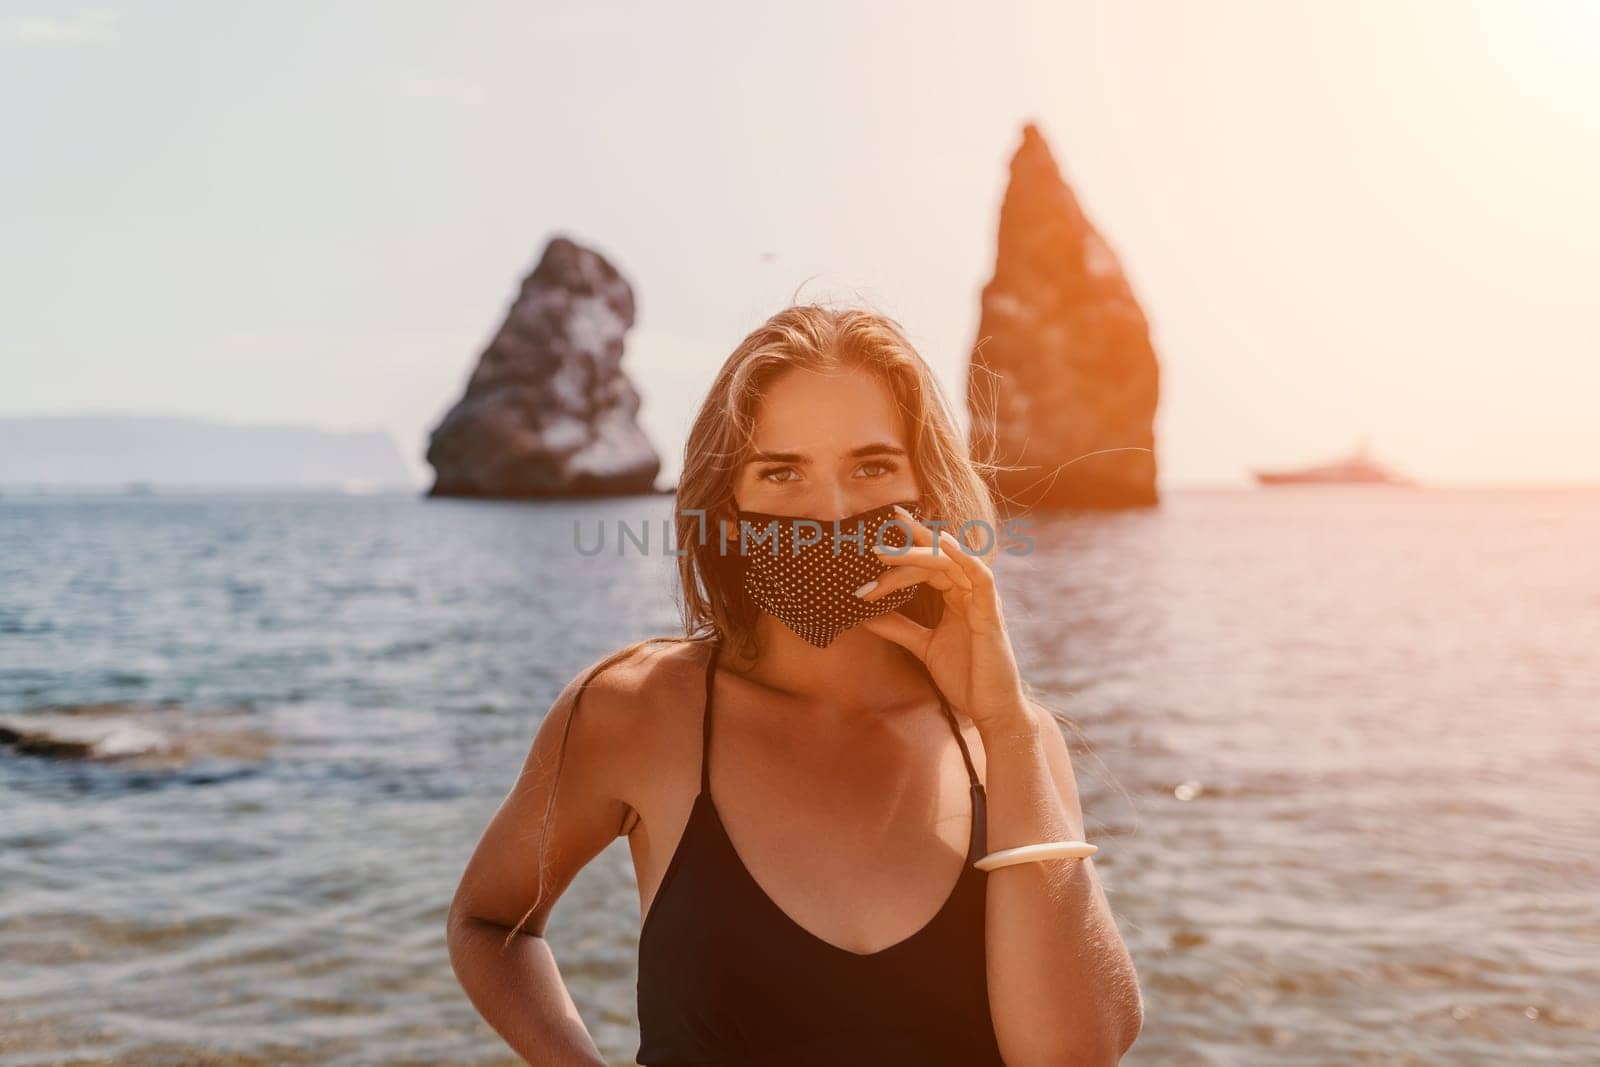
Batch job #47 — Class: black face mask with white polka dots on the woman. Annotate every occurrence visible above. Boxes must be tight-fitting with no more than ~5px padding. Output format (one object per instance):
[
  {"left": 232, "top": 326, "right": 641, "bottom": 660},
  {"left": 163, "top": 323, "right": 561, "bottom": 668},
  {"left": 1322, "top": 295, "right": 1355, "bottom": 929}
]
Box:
[{"left": 726, "top": 501, "right": 922, "bottom": 648}]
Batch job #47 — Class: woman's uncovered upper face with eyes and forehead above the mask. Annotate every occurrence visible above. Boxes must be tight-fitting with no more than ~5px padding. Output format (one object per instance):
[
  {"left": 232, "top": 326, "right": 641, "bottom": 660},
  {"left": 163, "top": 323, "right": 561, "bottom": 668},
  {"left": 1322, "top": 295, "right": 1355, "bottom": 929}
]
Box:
[{"left": 734, "top": 368, "right": 920, "bottom": 522}]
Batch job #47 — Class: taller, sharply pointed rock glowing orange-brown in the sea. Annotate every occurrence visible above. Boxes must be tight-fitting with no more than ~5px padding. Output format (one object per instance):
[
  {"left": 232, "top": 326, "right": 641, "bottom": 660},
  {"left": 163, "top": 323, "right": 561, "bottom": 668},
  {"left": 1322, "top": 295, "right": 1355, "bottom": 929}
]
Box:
[{"left": 966, "top": 123, "right": 1160, "bottom": 512}]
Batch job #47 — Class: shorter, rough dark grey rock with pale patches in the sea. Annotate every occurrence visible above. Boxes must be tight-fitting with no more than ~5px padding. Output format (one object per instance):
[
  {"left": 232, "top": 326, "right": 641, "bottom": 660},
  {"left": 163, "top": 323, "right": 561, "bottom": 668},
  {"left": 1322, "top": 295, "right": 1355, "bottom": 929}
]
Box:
[{"left": 427, "top": 237, "right": 661, "bottom": 498}]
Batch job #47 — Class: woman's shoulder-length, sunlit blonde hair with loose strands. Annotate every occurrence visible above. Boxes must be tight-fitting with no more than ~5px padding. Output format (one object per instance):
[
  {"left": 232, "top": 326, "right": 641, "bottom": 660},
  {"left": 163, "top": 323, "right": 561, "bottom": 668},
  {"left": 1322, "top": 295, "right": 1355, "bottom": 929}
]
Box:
[{"left": 506, "top": 304, "right": 1100, "bottom": 944}]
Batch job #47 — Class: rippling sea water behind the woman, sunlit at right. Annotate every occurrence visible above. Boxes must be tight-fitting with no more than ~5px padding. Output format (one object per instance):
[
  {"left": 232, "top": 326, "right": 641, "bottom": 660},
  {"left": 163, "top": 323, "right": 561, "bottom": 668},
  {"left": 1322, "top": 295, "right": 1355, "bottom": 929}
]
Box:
[{"left": 0, "top": 486, "right": 1600, "bottom": 1067}]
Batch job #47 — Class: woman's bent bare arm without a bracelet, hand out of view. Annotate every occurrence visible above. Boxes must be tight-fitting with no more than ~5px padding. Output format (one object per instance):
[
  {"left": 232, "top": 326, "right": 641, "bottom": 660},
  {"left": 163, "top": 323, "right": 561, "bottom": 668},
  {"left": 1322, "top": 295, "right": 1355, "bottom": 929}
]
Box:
[{"left": 446, "top": 667, "right": 629, "bottom": 1067}]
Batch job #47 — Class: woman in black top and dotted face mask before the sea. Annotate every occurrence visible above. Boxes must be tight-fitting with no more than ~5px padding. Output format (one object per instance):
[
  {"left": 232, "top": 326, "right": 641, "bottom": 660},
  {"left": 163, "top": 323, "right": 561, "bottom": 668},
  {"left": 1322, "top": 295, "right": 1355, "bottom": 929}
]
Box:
[{"left": 450, "top": 306, "right": 1142, "bottom": 1065}]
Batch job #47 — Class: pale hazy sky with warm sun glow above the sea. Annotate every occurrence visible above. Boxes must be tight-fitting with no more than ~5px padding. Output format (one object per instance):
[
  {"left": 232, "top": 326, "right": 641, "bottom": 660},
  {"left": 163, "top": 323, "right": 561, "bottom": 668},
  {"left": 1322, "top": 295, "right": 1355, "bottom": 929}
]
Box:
[{"left": 0, "top": 0, "right": 1600, "bottom": 488}]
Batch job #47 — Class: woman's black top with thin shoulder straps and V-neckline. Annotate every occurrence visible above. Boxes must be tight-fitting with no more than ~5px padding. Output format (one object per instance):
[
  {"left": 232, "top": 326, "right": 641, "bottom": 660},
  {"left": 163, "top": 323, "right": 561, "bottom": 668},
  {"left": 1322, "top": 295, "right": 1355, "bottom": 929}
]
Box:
[{"left": 635, "top": 640, "right": 1005, "bottom": 1067}]
